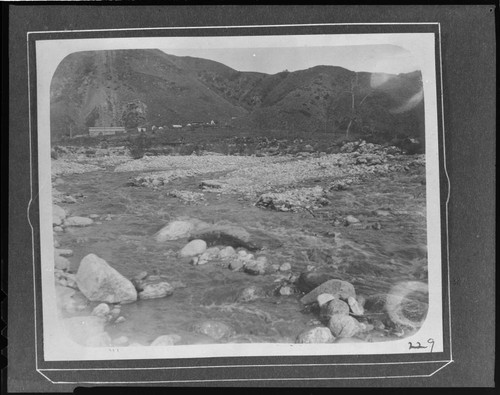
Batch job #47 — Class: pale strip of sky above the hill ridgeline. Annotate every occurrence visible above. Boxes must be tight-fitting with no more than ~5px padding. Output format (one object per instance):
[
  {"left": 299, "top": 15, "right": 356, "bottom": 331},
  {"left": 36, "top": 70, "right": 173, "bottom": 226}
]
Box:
[{"left": 162, "top": 44, "right": 419, "bottom": 74}]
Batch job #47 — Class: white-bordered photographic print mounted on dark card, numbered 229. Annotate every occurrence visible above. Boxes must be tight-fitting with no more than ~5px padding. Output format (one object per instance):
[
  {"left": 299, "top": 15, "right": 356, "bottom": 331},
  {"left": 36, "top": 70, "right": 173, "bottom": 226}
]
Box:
[{"left": 36, "top": 29, "right": 445, "bottom": 361}]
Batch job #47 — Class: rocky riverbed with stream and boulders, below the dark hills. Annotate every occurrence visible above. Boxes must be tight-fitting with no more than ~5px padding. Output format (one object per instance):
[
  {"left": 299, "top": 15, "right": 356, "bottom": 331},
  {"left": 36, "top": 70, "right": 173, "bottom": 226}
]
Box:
[{"left": 48, "top": 142, "right": 427, "bottom": 346}]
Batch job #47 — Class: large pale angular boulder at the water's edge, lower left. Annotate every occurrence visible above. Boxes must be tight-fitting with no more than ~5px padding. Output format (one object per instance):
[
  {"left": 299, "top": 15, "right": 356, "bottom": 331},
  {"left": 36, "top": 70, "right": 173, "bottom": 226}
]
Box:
[{"left": 76, "top": 254, "right": 137, "bottom": 303}]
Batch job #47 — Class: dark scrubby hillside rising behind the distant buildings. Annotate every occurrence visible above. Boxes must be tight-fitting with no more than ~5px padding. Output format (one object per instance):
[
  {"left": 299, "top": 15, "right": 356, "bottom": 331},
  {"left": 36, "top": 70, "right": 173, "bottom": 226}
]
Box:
[{"left": 51, "top": 50, "right": 424, "bottom": 140}]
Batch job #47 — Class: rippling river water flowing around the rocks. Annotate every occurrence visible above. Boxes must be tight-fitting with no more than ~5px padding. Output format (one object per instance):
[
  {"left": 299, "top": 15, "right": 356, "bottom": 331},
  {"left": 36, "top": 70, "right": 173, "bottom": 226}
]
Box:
[{"left": 57, "top": 162, "right": 427, "bottom": 344}]
